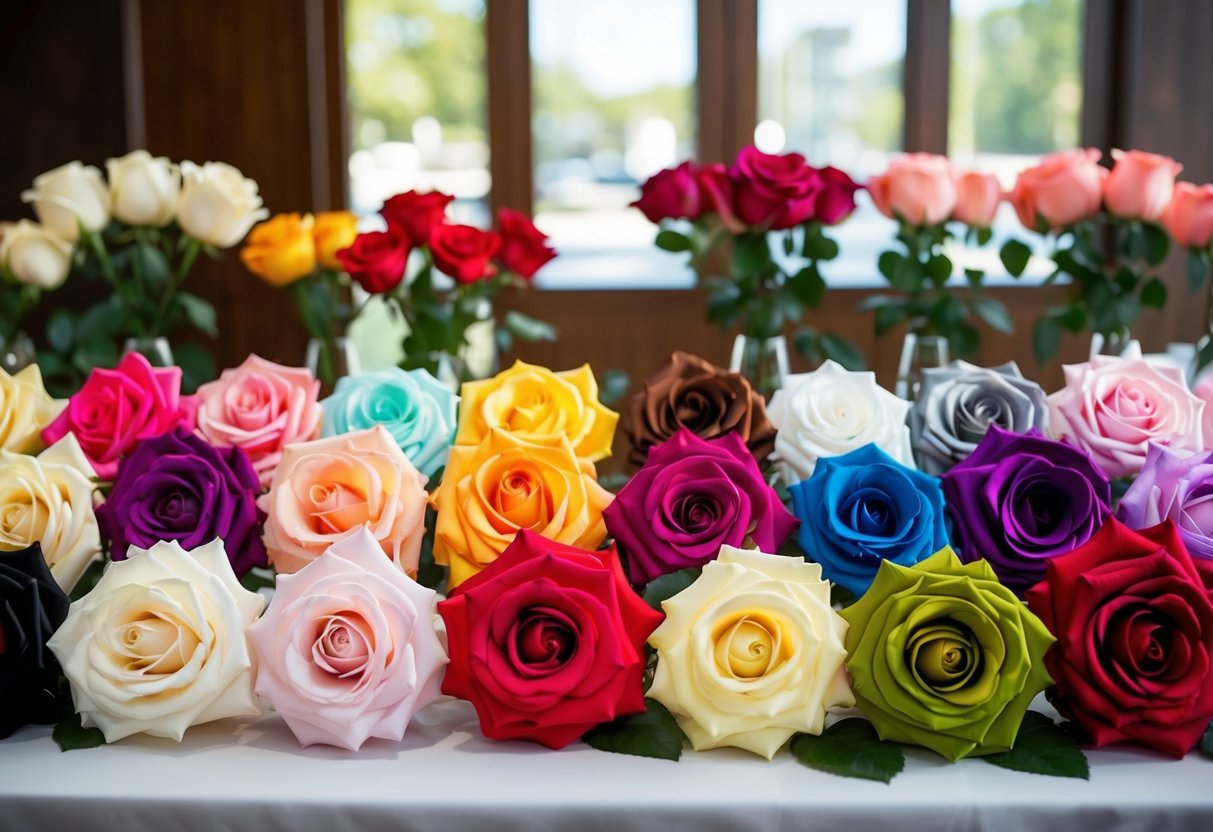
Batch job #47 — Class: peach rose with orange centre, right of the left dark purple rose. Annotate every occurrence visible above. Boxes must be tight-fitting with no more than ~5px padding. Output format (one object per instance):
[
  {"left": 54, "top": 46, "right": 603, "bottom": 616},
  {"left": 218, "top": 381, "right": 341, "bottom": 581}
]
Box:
[{"left": 257, "top": 424, "right": 426, "bottom": 575}]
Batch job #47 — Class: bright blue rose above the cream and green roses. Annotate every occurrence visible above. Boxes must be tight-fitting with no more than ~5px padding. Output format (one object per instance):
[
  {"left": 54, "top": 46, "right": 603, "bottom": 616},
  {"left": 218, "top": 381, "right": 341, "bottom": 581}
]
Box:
[{"left": 790, "top": 445, "right": 947, "bottom": 597}]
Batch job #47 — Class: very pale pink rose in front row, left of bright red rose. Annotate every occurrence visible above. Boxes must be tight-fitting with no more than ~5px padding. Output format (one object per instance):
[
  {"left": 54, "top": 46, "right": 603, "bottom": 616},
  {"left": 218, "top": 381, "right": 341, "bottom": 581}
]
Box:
[{"left": 249, "top": 528, "right": 448, "bottom": 751}]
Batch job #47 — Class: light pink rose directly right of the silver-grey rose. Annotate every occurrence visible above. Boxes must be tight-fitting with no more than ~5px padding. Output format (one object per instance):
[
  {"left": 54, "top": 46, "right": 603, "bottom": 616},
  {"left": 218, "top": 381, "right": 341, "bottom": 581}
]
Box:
[{"left": 1047, "top": 355, "right": 1205, "bottom": 477}]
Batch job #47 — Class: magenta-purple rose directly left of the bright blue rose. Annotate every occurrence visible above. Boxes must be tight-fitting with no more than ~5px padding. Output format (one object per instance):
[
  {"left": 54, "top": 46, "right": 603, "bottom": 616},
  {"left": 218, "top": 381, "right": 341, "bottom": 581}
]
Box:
[{"left": 603, "top": 428, "right": 797, "bottom": 583}]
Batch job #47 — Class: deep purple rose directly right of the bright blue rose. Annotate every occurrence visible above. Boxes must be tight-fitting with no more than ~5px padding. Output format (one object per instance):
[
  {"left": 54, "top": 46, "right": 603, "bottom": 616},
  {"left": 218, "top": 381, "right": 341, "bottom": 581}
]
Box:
[{"left": 943, "top": 424, "right": 1112, "bottom": 594}]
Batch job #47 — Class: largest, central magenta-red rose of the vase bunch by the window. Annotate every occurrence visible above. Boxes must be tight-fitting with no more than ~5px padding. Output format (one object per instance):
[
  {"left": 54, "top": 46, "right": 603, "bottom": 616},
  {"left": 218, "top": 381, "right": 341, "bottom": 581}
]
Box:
[{"left": 730, "top": 146, "right": 821, "bottom": 229}]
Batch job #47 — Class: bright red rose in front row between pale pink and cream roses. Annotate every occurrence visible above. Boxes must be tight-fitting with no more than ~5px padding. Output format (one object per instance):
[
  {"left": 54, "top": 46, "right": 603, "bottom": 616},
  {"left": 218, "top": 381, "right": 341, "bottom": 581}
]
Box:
[{"left": 438, "top": 530, "right": 662, "bottom": 748}]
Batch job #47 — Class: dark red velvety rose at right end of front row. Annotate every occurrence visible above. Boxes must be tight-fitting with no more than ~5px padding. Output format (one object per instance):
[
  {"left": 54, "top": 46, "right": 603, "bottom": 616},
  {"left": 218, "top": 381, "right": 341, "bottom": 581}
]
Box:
[{"left": 1026, "top": 519, "right": 1213, "bottom": 757}]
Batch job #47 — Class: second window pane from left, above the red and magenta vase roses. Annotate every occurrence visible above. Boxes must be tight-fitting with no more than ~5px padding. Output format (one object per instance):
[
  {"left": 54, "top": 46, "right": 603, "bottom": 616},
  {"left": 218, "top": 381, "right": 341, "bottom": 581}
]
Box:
[{"left": 530, "top": 0, "right": 695, "bottom": 289}]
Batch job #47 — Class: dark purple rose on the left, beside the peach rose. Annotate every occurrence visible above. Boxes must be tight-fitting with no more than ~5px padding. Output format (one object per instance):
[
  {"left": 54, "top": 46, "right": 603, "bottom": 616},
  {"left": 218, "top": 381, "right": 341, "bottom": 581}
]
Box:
[{"left": 97, "top": 428, "right": 267, "bottom": 576}]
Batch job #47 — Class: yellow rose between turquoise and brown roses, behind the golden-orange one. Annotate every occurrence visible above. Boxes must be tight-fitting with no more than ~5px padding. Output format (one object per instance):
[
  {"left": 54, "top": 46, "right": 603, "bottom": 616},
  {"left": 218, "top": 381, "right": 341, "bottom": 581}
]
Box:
[{"left": 455, "top": 361, "right": 619, "bottom": 462}]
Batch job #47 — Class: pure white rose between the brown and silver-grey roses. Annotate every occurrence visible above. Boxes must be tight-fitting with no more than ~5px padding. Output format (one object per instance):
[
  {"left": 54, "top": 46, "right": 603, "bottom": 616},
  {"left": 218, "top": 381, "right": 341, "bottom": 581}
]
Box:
[{"left": 767, "top": 361, "right": 913, "bottom": 485}]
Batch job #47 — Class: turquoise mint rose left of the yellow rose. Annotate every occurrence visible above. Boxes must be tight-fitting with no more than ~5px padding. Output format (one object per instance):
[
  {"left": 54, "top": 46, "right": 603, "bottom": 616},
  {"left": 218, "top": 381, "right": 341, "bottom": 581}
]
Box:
[{"left": 320, "top": 367, "right": 459, "bottom": 477}]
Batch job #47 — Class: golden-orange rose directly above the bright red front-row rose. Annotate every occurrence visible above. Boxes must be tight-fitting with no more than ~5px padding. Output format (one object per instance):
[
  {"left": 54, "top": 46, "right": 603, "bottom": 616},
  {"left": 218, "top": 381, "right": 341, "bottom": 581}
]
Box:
[{"left": 431, "top": 434, "right": 614, "bottom": 588}]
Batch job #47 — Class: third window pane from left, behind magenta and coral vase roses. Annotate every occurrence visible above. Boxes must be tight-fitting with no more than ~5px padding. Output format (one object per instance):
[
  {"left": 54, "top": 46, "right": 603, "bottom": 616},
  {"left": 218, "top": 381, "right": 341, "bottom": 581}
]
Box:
[{"left": 754, "top": 0, "right": 906, "bottom": 286}]
